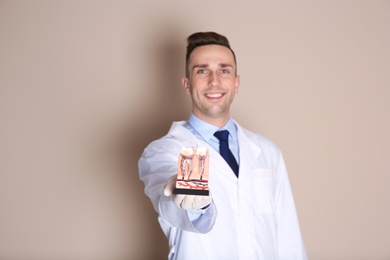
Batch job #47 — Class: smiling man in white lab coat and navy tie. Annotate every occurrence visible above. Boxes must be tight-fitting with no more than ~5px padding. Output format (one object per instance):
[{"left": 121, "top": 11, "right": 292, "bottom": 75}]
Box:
[{"left": 139, "top": 32, "right": 307, "bottom": 260}]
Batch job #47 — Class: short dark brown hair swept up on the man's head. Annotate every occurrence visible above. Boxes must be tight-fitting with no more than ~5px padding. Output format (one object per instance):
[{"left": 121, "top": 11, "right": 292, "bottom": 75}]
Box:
[{"left": 186, "top": 32, "right": 237, "bottom": 78}]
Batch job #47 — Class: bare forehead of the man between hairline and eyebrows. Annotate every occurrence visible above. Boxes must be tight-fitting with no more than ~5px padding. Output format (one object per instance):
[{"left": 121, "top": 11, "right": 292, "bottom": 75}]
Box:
[{"left": 190, "top": 44, "right": 234, "bottom": 66}]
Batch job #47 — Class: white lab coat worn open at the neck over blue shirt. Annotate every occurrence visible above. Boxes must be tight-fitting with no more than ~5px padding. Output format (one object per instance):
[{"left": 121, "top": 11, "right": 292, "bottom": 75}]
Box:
[{"left": 139, "top": 121, "right": 307, "bottom": 260}]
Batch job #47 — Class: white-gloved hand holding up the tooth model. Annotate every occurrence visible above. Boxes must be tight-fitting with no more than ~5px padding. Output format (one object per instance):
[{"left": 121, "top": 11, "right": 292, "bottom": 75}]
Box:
[{"left": 164, "top": 175, "right": 211, "bottom": 210}]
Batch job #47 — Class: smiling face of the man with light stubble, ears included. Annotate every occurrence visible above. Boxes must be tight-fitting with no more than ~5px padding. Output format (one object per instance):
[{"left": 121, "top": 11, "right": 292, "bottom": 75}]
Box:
[{"left": 182, "top": 45, "right": 240, "bottom": 126}]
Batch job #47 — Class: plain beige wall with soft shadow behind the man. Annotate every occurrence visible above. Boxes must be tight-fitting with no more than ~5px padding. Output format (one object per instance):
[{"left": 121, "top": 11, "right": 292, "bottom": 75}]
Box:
[{"left": 0, "top": 0, "right": 390, "bottom": 260}]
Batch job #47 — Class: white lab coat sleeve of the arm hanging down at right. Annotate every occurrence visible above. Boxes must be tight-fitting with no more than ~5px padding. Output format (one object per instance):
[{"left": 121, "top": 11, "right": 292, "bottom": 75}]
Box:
[{"left": 276, "top": 151, "right": 307, "bottom": 260}]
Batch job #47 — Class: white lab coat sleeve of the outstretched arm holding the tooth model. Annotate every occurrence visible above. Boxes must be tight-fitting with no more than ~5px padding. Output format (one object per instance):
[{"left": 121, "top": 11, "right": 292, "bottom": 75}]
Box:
[{"left": 138, "top": 139, "right": 216, "bottom": 233}]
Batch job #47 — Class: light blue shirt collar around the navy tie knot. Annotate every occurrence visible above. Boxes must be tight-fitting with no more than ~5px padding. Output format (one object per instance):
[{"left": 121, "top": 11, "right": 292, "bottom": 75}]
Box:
[{"left": 188, "top": 113, "right": 237, "bottom": 141}]
